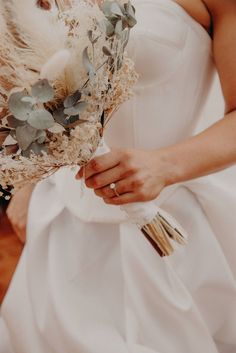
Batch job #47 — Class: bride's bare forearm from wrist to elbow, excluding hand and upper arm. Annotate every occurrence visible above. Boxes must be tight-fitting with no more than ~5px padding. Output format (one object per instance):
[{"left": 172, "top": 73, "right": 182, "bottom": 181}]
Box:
[{"left": 162, "top": 111, "right": 236, "bottom": 185}]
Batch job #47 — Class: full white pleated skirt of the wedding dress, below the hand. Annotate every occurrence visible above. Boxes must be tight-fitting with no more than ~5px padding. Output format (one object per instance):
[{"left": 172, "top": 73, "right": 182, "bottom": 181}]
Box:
[{"left": 0, "top": 166, "right": 236, "bottom": 353}]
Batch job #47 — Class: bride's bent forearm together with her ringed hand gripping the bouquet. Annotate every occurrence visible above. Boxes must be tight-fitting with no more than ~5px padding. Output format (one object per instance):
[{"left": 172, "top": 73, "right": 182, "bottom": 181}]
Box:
[{"left": 78, "top": 112, "right": 236, "bottom": 205}]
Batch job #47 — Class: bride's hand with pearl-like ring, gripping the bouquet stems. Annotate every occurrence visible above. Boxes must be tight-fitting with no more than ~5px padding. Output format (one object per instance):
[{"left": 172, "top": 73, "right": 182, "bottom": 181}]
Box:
[{"left": 77, "top": 149, "right": 171, "bottom": 205}]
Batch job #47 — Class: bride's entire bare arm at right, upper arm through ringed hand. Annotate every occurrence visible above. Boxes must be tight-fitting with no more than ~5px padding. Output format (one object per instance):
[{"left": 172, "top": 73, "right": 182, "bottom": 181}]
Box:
[{"left": 79, "top": 0, "right": 236, "bottom": 205}]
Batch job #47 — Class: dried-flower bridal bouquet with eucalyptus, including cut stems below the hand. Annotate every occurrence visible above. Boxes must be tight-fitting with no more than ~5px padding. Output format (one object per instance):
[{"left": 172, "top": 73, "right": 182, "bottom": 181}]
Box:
[{"left": 0, "top": 0, "right": 186, "bottom": 256}]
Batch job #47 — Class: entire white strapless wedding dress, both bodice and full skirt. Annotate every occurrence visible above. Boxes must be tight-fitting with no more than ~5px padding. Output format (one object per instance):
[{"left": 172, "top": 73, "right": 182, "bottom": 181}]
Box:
[{"left": 0, "top": 0, "right": 236, "bottom": 353}]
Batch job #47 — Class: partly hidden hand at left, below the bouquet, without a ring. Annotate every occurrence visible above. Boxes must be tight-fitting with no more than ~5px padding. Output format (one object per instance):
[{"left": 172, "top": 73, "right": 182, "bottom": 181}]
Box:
[{"left": 7, "top": 184, "right": 34, "bottom": 243}]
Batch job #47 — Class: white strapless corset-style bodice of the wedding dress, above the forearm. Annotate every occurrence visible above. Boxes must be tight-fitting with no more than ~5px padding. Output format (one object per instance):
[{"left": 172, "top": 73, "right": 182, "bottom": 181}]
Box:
[{"left": 106, "top": 0, "right": 214, "bottom": 148}]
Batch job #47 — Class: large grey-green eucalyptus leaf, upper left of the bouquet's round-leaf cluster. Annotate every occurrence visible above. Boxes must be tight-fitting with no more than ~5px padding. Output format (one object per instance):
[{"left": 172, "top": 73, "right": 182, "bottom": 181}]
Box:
[{"left": 8, "top": 90, "right": 32, "bottom": 121}]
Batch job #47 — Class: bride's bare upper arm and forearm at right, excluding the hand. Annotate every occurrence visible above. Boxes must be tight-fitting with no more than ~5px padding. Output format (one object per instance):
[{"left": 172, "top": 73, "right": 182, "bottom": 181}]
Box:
[{"left": 164, "top": 0, "right": 236, "bottom": 184}]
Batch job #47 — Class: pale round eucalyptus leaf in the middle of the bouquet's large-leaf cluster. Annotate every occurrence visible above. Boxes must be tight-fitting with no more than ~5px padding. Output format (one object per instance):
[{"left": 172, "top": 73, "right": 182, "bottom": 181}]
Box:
[{"left": 28, "top": 109, "right": 54, "bottom": 130}]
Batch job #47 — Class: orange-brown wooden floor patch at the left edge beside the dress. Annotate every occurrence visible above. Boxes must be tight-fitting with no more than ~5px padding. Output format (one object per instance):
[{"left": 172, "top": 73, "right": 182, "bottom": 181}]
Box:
[{"left": 0, "top": 210, "right": 22, "bottom": 303}]
